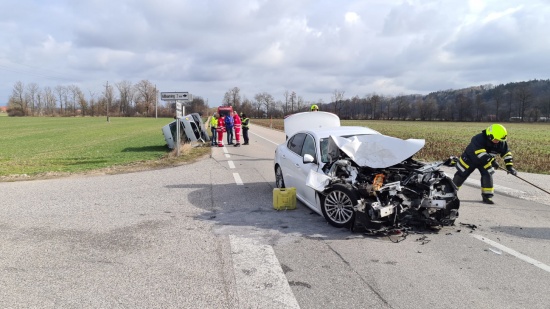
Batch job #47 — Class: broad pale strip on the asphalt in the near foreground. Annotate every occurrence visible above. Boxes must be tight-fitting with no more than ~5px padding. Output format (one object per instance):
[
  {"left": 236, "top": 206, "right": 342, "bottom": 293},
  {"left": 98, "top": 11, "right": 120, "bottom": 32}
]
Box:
[{"left": 229, "top": 235, "right": 300, "bottom": 308}]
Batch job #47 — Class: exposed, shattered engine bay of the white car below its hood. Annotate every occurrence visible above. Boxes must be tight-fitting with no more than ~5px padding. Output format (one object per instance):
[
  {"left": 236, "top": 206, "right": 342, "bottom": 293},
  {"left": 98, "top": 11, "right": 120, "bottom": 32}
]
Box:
[{"left": 325, "top": 159, "right": 460, "bottom": 231}]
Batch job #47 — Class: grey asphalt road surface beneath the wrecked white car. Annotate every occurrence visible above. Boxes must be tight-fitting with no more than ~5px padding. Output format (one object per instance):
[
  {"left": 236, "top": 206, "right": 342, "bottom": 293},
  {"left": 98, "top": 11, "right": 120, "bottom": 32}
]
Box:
[{"left": 0, "top": 126, "right": 550, "bottom": 308}]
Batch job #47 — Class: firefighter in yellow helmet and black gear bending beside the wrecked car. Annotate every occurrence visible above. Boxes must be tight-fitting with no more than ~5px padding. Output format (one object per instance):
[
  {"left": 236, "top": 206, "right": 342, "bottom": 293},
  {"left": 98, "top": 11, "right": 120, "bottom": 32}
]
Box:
[{"left": 453, "top": 124, "right": 517, "bottom": 204}]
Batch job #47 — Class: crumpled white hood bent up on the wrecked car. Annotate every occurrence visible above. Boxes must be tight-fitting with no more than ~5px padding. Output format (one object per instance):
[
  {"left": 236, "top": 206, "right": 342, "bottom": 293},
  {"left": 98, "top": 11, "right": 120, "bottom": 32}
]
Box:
[{"left": 328, "top": 134, "right": 426, "bottom": 168}]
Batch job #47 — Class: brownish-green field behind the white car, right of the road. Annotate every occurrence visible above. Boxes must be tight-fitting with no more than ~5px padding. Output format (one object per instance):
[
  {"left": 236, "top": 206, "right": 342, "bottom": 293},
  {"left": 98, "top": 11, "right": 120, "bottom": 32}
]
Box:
[{"left": 251, "top": 119, "right": 550, "bottom": 174}]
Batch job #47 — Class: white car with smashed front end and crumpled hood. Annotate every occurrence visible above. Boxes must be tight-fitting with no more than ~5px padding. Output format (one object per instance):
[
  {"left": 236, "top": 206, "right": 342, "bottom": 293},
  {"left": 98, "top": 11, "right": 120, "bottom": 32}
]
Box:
[{"left": 274, "top": 112, "right": 460, "bottom": 233}]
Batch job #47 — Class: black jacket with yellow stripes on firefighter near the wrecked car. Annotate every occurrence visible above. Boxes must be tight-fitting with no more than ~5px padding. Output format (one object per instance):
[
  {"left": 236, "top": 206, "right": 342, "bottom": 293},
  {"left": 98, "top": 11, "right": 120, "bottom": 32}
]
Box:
[{"left": 463, "top": 130, "right": 514, "bottom": 169}]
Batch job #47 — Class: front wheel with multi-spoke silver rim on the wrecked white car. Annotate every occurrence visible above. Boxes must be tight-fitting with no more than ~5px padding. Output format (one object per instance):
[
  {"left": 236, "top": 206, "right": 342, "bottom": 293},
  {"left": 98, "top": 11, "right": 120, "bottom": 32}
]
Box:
[{"left": 321, "top": 184, "right": 357, "bottom": 228}]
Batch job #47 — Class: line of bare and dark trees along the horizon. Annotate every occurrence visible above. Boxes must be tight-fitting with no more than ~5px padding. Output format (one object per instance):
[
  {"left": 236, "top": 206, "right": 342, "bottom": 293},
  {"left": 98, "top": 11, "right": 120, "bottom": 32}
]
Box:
[{"left": 8, "top": 80, "right": 550, "bottom": 122}]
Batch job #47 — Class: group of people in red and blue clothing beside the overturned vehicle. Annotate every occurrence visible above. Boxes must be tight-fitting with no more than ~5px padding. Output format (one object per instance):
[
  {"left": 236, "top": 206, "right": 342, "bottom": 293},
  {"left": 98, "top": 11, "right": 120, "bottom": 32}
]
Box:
[{"left": 210, "top": 112, "right": 250, "bottom": 147}]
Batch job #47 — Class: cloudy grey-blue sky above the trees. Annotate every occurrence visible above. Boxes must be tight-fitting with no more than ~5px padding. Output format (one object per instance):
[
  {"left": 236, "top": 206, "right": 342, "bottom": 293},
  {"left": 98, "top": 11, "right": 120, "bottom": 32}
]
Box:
[{"left": 0, "top": 0, "right": 550, "bottom": 106}]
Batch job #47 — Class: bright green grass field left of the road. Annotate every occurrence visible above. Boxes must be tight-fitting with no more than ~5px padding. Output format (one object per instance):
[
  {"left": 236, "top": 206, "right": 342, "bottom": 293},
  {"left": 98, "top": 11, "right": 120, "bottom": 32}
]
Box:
[{"left": 0, "top": 117, "right": 210, "bottom": 180}]
